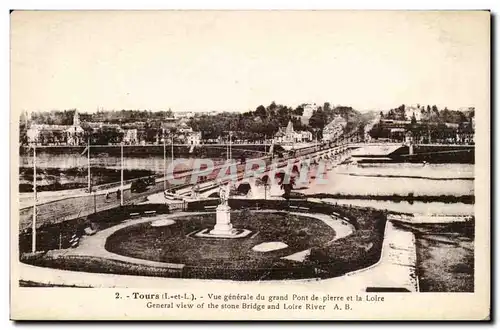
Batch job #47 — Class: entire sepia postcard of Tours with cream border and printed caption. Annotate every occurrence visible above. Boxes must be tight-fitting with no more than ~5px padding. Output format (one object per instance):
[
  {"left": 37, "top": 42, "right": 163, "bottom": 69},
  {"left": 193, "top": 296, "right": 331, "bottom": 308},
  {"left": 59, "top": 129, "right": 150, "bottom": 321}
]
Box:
[{"left": 10, "top": 10, "right": 491, "bottom": 320}]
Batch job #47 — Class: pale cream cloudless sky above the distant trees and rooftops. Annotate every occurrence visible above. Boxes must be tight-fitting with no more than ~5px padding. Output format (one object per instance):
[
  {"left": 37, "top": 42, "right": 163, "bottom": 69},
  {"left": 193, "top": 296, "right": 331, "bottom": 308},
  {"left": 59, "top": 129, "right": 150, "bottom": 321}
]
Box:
[{"left": 11, "top": 11, "right": 490, "bottom": 112}]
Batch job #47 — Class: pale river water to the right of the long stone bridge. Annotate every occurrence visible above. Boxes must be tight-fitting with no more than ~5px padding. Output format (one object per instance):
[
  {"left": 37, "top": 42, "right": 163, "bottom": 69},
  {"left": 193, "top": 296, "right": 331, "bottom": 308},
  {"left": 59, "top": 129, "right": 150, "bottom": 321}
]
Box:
[{"left": 306, "top": 163, "right": 474, "bottom": 215}]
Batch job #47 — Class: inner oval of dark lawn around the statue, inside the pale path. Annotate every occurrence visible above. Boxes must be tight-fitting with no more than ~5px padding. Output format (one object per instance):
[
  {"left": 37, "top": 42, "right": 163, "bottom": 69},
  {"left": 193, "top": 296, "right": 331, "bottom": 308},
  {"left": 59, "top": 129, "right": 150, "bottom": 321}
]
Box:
[{"left": 106, "top": 212, "right": 335, "bottom": 272}]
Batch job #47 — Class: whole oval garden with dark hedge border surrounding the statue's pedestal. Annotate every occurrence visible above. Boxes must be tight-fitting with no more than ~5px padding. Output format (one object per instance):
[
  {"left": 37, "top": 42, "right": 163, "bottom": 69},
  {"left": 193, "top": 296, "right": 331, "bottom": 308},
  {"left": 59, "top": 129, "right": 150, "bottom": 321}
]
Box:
[{"left": 22, "top": 200, "right": 387, "bottom": 280}]
